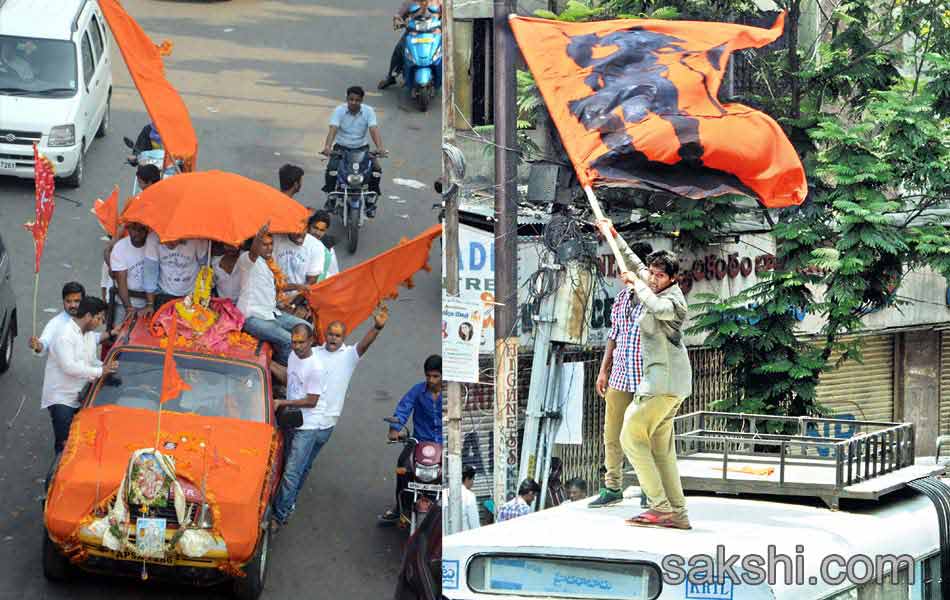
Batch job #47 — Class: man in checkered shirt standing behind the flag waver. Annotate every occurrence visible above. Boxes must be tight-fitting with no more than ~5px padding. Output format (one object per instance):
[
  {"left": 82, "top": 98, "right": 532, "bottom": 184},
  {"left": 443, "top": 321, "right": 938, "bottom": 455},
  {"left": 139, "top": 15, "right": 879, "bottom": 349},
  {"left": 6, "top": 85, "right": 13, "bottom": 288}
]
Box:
[{"left": 587, "top": 243, "right": 653, "bottom": 508}]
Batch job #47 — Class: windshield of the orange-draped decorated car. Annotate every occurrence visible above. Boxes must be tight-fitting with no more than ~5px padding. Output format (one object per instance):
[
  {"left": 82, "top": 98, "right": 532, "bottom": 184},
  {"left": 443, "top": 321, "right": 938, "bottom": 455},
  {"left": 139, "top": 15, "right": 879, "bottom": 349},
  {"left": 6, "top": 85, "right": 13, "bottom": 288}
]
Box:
[{"left": 92, "top": 350, "right": 266, "bottom": 423}]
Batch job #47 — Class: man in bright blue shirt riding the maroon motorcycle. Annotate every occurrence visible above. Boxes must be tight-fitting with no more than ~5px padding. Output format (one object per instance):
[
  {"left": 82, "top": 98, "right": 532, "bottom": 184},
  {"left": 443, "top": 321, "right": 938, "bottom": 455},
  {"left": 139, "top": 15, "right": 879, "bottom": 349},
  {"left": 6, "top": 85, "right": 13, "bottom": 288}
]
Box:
[{"left": 379, "top": 354, "right": 442, "bottom": 523}]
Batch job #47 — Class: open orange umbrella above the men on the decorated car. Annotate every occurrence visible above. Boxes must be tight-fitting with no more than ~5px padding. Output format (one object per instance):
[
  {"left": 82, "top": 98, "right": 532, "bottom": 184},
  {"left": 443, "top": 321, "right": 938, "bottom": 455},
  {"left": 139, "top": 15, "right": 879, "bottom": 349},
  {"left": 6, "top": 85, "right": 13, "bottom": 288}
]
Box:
[{"left": 122, "top": 171, "right": 310, "bottom": 246}]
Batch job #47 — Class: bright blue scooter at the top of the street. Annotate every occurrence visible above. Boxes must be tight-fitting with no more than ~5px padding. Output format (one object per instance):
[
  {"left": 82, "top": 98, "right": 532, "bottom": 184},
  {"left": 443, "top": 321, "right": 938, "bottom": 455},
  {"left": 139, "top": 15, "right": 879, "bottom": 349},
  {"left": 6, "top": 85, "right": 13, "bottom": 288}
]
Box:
[{"left": 400, "top": 5, "right": 442, "bottom": 112}]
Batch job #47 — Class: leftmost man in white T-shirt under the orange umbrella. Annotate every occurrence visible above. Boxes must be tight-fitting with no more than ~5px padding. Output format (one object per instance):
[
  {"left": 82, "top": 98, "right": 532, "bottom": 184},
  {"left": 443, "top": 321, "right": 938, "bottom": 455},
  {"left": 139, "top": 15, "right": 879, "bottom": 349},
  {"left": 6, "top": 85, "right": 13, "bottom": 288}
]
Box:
[{"left": 109, "top": 223, "right": 158, "bottom": 323}]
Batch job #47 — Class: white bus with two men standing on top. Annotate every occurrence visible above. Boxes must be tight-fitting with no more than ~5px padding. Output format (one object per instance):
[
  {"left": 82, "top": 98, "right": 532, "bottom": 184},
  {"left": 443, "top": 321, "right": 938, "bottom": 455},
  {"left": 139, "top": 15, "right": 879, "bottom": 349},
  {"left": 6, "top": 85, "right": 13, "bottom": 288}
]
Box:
[{"left": 442, "top": 486, "right": 950, "bottom": 600}]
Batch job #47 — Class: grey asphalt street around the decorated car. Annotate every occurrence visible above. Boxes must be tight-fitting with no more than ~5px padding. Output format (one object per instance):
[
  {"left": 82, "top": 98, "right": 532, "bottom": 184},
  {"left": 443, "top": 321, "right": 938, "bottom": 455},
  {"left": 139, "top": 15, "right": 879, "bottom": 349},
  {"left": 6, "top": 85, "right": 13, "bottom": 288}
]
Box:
[{"left": 0, "top": 0, "right": 440, "bottom": 600}]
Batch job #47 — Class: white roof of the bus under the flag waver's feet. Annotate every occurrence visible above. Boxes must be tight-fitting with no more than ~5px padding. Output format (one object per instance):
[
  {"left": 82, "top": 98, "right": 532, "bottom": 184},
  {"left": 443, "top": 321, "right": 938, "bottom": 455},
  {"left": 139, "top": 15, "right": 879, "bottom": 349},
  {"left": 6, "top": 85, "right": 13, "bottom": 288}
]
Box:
[{"left": 443, "top": 493, "right": 940, "bottom": 600}]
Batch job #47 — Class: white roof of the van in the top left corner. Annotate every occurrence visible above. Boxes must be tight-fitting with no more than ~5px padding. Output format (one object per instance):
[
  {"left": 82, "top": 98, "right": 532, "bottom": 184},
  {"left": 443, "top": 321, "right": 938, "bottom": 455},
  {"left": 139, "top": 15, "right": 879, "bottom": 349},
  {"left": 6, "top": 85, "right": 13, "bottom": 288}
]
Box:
[{"left": 0, "top": 0, "right": 88, "bottom": 40}]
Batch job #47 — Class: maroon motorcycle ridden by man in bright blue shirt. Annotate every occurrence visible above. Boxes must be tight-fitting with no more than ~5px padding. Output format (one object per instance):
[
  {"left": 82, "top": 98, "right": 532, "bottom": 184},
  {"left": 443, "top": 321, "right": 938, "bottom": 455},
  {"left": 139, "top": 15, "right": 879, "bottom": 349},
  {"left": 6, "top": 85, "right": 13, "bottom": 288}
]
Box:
[{"left": 383, "top": 418, "right": 442, "bottom": 535}]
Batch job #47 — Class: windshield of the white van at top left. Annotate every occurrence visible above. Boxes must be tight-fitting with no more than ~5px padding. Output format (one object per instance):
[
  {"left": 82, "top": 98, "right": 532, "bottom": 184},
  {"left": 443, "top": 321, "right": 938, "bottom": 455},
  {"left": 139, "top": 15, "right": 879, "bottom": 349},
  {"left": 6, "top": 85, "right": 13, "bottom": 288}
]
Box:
[{"left": 0, "top": 35, "right": 78, "bottom": 97}]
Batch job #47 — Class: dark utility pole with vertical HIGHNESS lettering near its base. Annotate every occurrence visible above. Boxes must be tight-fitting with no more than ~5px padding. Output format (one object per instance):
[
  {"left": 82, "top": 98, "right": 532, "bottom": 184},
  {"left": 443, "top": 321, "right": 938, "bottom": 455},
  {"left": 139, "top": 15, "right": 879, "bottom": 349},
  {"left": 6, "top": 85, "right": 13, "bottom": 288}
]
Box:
[{"left": 492, "top": 0, "right": 518, "bottom": 516}]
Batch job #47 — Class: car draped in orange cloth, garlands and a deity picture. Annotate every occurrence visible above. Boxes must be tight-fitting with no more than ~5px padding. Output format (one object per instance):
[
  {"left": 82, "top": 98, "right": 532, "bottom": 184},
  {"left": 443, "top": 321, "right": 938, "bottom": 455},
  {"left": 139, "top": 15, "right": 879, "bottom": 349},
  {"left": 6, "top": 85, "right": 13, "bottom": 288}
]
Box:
[{"left": 43, "top": 298, "right": 299, "bottom": 599}]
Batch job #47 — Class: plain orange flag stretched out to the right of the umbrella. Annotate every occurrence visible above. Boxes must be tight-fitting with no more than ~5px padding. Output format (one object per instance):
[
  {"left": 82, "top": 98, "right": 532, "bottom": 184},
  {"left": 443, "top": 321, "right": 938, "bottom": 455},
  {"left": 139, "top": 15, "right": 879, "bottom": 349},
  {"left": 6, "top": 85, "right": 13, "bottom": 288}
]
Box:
[{"left": 306, "top": 225, "right": 442, "bottom": 338}]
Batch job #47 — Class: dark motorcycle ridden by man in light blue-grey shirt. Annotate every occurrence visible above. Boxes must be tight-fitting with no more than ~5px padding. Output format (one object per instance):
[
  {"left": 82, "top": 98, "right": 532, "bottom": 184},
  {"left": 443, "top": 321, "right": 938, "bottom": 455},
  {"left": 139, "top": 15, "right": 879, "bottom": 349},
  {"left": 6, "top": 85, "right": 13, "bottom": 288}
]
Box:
[{"left": 328, "top": 149, "right": 381, "bottom": 254}]
